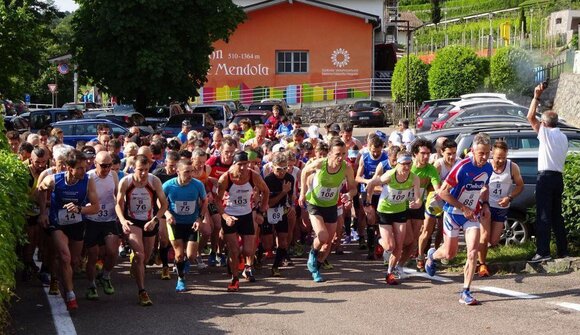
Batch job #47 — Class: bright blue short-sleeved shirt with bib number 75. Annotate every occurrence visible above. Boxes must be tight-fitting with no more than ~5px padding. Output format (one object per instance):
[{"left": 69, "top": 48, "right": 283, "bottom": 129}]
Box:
[{"left": 163, "top": 177, "right": 206, "bottom": 225}]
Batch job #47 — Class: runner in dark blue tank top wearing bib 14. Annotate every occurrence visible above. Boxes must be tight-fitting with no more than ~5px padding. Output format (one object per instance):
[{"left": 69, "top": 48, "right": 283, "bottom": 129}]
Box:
[{"left": 38, "top": 150, "right": 100, "bottom": 311}]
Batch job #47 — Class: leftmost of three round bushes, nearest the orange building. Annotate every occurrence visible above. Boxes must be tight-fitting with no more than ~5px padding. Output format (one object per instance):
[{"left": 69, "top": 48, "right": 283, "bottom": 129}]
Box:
[{"left": 391, "top": 55, "right": 429, "bottom": 102}]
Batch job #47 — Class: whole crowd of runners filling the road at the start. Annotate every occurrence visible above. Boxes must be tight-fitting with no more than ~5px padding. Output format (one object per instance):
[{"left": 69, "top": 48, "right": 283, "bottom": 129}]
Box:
[{"left": 7, "top": 106, "right": 523, "bottom": 310}]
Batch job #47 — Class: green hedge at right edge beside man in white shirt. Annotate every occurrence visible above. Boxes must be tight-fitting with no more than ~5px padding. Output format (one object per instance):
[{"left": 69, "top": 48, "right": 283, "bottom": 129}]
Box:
[{"left": 562, "top": 153, "right": 580, "bottom": 245}]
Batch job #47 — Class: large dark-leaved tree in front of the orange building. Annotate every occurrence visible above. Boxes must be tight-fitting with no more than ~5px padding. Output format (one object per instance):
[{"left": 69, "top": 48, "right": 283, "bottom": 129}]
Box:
[{"left": 72, "top": 0, "right": 245, "bottom": 111}]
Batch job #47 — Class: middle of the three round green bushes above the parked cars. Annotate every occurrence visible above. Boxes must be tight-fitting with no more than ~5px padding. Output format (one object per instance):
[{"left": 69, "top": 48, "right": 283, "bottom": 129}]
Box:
[{"left": 429, "top": 45, "right": 484, "bottom": 99}]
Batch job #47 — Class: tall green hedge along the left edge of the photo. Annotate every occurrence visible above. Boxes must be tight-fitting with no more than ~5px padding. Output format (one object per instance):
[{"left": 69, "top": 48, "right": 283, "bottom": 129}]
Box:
[{"left": 0, "top": 117, "right": 29, "bottom": 330}]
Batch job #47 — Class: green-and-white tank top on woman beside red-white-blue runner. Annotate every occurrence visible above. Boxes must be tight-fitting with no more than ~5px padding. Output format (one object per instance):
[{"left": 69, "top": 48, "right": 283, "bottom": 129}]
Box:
[{"left": 377, "top": 169, "right": 415, "bottom": 214}]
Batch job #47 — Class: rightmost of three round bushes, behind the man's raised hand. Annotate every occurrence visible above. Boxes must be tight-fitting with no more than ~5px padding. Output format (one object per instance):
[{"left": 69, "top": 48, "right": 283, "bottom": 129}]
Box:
[{"left": 490, "top": 46, "right": 534, "bottom": 95}]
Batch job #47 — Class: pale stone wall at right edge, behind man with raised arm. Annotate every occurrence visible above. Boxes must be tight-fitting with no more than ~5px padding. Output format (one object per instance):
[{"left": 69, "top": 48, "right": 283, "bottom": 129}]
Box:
[{"left": 553, "top": 73, "right": 580, "bottom": 127}]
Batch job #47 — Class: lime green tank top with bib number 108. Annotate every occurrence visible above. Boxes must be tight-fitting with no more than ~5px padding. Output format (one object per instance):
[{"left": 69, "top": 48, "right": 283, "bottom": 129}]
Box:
[{"left": 306, "top": 159, "right": 346, "bottom": 207}]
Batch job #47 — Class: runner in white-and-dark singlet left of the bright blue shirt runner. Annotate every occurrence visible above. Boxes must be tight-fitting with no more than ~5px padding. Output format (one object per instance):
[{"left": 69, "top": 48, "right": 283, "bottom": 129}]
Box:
[{"left": 115, "top": 155, "right": 167, "bottom": 306}]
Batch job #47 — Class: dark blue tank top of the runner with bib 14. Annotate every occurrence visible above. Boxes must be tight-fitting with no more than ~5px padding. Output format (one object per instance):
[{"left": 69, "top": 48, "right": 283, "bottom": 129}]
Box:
[{"left": 49, "top": 172, "right": 89, "bottom": 226}]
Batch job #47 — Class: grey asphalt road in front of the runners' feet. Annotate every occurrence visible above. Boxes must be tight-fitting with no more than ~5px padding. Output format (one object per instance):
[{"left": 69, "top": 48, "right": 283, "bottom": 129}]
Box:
[{"left": 11, "top": 245, "right": 580, "bottom": 334}]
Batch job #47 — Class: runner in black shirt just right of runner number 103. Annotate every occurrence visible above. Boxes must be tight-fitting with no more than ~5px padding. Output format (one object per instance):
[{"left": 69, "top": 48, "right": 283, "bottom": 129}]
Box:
[{"left": 261, "top": 152, "right": 295, "bottom": 277}]
